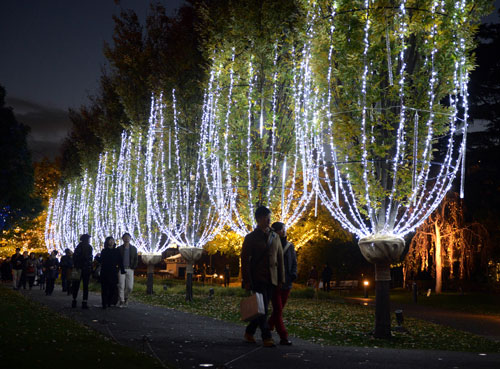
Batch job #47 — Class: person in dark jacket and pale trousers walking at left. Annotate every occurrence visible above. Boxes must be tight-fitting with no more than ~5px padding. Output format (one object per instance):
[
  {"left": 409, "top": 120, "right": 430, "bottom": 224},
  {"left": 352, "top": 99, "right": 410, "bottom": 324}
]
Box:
[{"left": 118, "top": 233, "right": 138, "bottom": 307}]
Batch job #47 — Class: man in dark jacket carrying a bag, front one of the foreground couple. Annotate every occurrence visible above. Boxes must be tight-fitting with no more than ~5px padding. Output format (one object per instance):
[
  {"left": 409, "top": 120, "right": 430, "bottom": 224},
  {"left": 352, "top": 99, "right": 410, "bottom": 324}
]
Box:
[{"left": 241, "top": 206, "right": 285, "bottom": 347}]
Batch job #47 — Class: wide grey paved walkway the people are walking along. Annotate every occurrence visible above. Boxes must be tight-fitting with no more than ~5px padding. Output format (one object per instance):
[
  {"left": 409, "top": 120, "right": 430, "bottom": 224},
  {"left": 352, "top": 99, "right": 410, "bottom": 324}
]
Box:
[{"left": 16, "top": 287, "right": 500, "bottom": 369}]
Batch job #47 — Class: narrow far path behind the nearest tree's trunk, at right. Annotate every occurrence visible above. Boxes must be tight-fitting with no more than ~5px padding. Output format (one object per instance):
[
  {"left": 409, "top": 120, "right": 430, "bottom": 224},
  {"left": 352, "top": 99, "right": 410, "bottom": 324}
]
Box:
[{"left": 344, "top": 297, "right": 500, "bottom": 342}]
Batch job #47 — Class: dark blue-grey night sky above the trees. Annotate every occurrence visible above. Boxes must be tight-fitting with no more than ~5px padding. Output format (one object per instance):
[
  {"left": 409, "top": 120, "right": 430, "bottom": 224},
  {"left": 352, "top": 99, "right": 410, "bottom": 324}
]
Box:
[{"left": 0, "top": 0, "right": 500, "bottom": 160}]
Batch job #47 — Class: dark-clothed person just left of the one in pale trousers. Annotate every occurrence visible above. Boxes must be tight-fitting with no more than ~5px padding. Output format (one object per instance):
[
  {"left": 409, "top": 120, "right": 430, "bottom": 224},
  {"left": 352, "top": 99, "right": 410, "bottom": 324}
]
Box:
[{"left": 100, "top": 236, "right": 125, "bottom": 309}]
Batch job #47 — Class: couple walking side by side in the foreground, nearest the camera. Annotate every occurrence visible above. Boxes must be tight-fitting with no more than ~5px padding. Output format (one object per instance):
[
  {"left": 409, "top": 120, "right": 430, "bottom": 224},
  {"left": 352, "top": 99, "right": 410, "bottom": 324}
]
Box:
[{"left": 241, "top": 206, "right": 297, "bottom": 347}]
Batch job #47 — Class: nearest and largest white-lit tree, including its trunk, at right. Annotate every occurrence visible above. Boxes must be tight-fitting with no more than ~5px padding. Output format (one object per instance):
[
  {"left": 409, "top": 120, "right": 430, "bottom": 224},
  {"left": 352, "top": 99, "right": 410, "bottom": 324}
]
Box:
[{"left": 303, "top": 0, "right": 488, "bottom": 338}]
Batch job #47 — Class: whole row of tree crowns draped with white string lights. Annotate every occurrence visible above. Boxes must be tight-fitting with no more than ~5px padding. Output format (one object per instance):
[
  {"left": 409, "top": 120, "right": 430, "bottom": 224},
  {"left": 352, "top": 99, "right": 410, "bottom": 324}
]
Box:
[{"left": 46, "top": 0, "right": 484, "bottom": 258}]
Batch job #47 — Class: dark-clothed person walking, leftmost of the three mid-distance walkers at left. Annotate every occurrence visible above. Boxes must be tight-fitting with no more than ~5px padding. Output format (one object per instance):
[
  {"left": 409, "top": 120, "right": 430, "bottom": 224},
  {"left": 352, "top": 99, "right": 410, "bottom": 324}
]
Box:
[{"left": 71, "top": 234, "right": 93, "bottom": 309}]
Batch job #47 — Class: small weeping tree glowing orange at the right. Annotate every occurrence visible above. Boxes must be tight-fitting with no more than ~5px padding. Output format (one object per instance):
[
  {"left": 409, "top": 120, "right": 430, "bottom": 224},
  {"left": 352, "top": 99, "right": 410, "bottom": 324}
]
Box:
[{"left": 403, "top": 192, "right": 489, "bottom": 294}]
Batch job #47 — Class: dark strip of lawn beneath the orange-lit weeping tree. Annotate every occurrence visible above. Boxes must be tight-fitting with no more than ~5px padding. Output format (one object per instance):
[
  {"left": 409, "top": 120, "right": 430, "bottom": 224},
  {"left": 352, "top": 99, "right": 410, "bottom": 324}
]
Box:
[{"left": 391, "top": 289, "right": 500, "bottom": 316}]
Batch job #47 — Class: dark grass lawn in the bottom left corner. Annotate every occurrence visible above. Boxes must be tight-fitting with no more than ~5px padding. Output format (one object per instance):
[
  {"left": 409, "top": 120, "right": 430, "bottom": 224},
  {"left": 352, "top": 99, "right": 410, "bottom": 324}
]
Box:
[{"left": 0, "top": 285, "right": 167, "bottom": 369}]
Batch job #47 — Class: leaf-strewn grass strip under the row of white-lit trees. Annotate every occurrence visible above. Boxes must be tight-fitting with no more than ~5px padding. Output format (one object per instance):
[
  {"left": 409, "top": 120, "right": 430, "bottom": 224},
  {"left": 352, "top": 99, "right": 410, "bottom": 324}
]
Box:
[{"left": 96, "top": 278, "right": 500, "bottom": 352}]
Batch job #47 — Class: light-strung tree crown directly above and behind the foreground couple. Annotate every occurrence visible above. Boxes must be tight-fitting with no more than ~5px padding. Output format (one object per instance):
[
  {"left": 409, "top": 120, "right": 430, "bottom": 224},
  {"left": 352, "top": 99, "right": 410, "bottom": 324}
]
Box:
[{"left": 201, "top": 0, "right": 313, "bottom": 236}]
